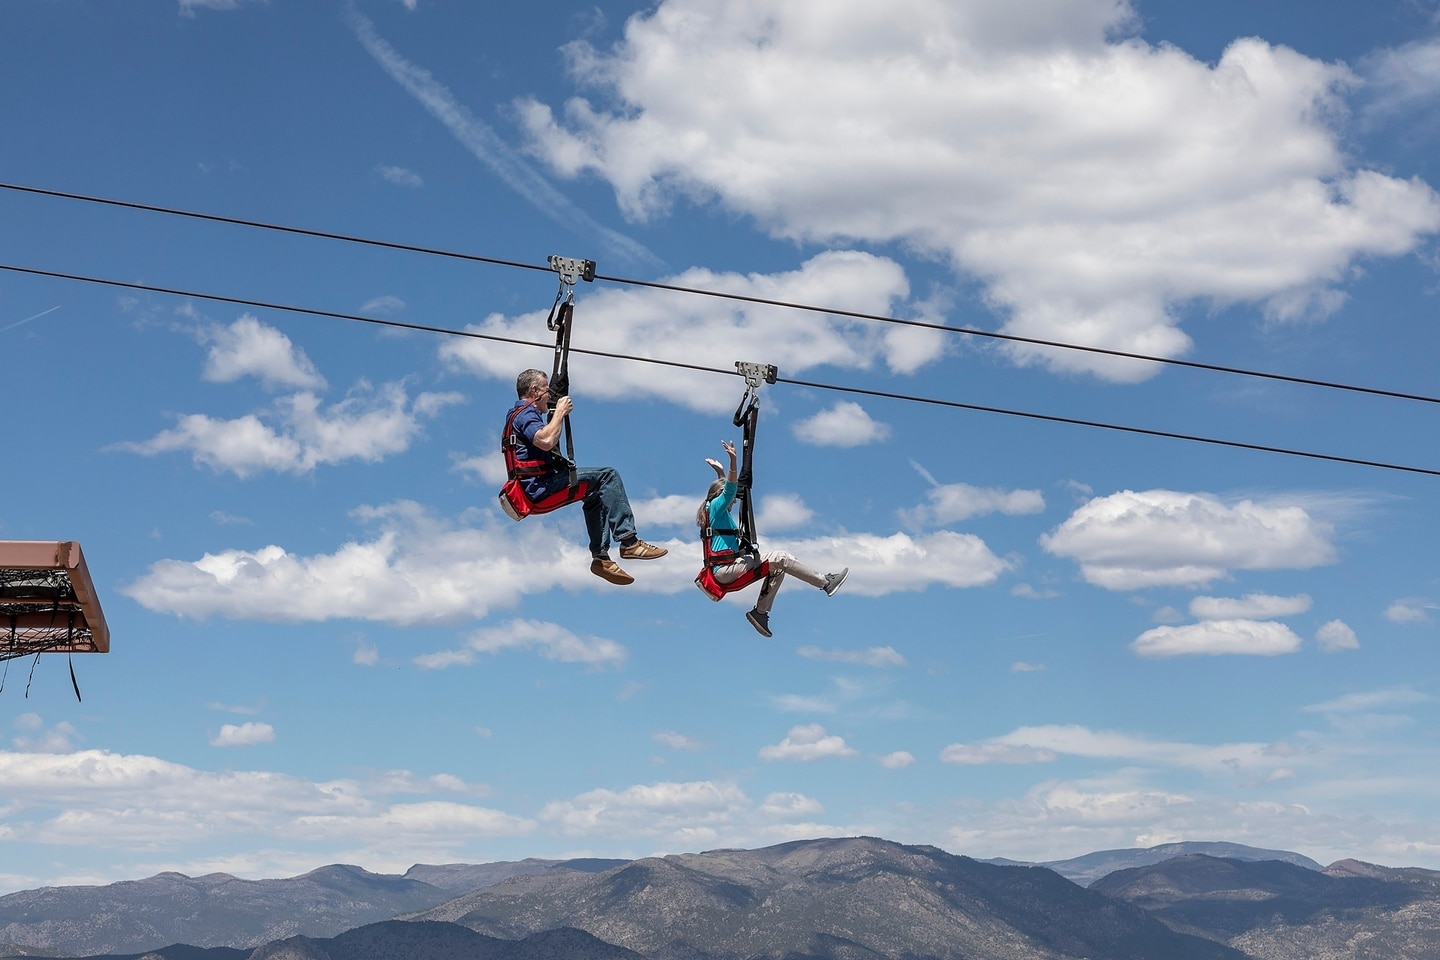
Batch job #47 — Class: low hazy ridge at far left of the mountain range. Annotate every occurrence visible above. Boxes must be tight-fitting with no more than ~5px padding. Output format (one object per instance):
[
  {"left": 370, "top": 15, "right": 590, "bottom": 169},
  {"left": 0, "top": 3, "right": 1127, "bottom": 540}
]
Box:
[{"left": 0, "top": 859, "right": 613, "bottom": 960}]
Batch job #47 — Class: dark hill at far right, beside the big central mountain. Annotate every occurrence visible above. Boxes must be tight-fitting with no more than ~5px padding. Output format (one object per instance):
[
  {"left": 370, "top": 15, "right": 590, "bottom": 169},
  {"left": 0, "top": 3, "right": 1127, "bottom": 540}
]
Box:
[{"left": 1090, "top": 856, "right": 1440, "bottom": 960}]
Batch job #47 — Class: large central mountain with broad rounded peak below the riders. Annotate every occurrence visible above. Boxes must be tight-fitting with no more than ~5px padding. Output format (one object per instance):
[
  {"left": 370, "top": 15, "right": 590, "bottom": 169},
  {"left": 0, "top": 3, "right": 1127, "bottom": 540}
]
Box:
[{"left": 411, "top": 838, "right": 1244, "bottom": 960}]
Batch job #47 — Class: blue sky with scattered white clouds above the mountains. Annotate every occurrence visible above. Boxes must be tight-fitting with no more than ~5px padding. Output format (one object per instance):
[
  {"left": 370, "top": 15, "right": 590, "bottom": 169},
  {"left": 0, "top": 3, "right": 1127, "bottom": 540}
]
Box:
[{"left": 0, "top": 0, "right": 1440, "bottom": 892}]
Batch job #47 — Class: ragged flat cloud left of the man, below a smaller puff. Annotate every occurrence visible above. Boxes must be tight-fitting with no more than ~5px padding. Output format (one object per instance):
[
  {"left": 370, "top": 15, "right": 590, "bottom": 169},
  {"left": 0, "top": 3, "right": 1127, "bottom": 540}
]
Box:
[{"left": 114, "top": 383, "right": 464, "bottom": 478}]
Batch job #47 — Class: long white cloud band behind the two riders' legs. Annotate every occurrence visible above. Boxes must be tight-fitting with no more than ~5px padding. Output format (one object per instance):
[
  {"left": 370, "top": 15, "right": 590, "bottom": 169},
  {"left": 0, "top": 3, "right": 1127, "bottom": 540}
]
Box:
[{"left": 121, "top": 501, "right": 1009, "bottom": 627}]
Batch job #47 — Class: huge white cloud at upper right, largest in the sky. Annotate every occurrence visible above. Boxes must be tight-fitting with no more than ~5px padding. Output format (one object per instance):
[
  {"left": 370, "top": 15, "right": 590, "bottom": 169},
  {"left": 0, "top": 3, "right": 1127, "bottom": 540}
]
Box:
[{"left": 517, "top": 0, "right": 1440, "bottom": 380}]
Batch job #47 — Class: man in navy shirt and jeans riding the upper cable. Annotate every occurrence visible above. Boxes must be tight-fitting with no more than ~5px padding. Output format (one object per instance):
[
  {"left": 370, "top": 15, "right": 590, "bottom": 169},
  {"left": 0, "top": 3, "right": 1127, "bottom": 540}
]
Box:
[{"left": 505, "top": 370, "right": 668, "bottom": 584}]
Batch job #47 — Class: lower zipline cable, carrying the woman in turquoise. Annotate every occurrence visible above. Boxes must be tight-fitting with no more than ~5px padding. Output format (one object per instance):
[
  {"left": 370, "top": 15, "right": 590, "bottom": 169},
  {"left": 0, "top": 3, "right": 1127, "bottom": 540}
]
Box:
[{"left": 0, "top": 263, "right": 1440, "bottom": 476}]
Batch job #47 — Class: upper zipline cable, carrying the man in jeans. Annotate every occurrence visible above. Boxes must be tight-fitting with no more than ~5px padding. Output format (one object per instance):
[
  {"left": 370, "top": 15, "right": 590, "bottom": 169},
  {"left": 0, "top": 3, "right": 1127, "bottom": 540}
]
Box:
[{"left": 8, "top": 183, "right": 1440, "bottom": 403}]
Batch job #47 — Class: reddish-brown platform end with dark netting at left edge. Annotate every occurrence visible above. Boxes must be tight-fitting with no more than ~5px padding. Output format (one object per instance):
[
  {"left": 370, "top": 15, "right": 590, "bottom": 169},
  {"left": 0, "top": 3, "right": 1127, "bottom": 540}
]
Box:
[{"left": 0, "top": 540, "right": 109, "bottom": 661}]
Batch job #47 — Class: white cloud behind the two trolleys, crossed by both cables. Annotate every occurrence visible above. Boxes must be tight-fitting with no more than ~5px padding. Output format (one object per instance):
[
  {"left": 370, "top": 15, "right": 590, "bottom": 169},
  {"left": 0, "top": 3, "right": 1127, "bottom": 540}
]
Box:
[{"left": 439, "top": 250, "right": 943, "bottom": 419}]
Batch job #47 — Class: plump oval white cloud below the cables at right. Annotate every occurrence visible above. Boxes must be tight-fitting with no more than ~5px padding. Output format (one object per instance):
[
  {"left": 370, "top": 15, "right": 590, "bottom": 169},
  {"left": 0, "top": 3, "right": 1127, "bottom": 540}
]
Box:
[{"left": 1040, "top": 489, "right": 1335, "bottom": 590}]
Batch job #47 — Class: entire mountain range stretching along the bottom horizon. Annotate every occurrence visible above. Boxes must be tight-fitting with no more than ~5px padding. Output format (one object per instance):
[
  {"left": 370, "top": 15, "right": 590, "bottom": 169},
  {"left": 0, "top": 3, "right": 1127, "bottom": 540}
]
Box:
[{"left": 0, "top": 838, "right": 1440, "bottom": 960}]
